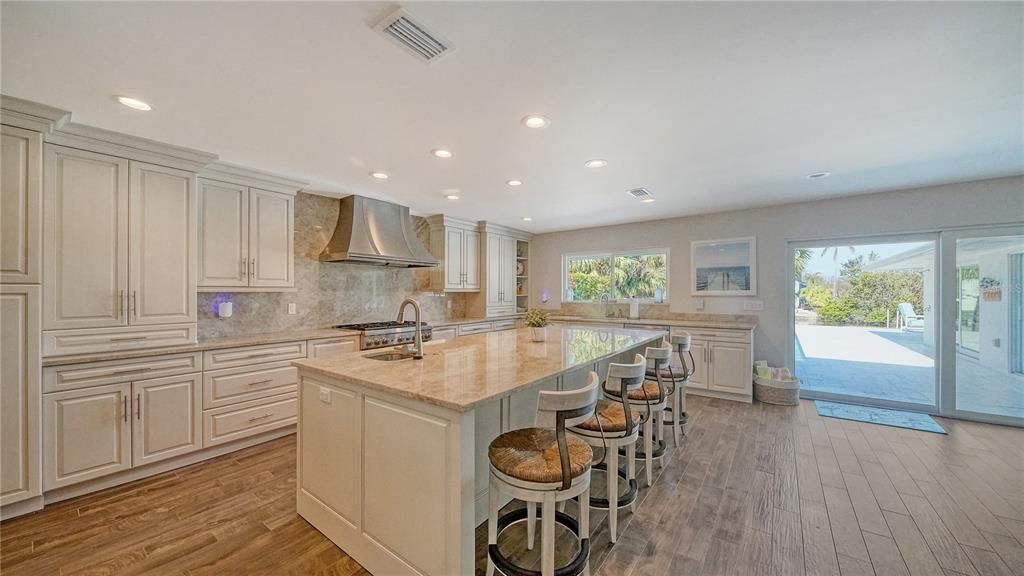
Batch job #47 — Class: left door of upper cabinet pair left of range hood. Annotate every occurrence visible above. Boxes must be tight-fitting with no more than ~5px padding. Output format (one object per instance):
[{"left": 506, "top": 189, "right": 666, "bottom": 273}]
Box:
[{"left": 199, "top": 179, "right": 249, "bottom": 287}]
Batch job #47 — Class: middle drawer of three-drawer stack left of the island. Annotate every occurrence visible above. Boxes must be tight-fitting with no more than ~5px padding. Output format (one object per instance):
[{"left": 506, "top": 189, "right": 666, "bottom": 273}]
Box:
[{"left": 203, "top": 362, "right": 299, "bottom": 410}]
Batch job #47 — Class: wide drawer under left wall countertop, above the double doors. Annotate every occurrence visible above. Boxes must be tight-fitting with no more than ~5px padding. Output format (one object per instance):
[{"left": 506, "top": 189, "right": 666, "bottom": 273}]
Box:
[{"left": 43, "top": 352, "right": 203, "bottom": 392}]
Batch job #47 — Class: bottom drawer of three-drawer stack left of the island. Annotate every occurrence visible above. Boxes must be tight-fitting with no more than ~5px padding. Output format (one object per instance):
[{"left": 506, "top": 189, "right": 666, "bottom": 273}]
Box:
[{"left": 203, "top": 393, "right": 298, "bottom": 448}]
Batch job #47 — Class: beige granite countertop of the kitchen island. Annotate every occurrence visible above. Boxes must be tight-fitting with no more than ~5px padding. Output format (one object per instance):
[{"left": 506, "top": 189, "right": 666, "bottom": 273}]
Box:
[{"left": 292, "top": 326, "right": 662, "bottom": 412}]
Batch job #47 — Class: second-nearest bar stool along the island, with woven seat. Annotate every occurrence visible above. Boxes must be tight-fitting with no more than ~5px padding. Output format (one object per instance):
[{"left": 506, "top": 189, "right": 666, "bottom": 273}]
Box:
[{"left": 569, "top": 354, "right": 647, "bottom": 543}]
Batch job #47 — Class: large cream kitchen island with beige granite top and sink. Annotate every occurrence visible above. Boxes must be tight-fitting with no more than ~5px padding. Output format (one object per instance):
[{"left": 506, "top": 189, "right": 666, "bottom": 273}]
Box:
[{"left": 293, "top": 326, "right": 664, "bottom": 576}]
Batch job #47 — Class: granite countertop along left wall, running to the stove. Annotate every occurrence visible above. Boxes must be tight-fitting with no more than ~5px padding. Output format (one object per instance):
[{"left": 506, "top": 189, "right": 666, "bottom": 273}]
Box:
[{"left": 43, "top": 328, "right": 358, "bottom": 366}]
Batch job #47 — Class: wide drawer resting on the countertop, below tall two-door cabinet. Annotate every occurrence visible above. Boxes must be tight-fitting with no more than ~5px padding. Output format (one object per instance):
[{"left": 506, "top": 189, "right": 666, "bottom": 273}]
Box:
[{"left": 43, "top": 324, "right": 196, "bottom": 356}]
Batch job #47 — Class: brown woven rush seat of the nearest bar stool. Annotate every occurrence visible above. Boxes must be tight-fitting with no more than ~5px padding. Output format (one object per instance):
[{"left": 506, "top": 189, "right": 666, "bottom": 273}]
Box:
[{"left": 487, "top": 428, "right": 594, "bottom": 483}]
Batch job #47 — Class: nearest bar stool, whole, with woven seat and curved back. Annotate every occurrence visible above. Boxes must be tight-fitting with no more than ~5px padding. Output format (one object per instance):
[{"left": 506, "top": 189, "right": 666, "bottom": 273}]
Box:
[{"left": 487, "top": 375, "right": 600, "bottom": 576}]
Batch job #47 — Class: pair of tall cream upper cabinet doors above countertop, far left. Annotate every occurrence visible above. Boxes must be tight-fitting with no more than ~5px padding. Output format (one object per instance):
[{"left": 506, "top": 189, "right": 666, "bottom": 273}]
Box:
[{"left": 43, "top": 145, "right": 196, "bottom": 330}]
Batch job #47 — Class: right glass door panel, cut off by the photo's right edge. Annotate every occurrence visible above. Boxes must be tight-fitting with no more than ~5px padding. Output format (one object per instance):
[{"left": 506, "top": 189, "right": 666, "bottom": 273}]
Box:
[{"left": 942, "top": 227, "right": 1024, "bottom": 425}]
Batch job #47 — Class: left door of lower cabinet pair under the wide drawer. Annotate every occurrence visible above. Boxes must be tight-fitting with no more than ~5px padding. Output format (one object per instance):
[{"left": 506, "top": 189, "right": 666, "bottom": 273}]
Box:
[{"left": 43, "top": 384, "right": 131, "bottom": 490}]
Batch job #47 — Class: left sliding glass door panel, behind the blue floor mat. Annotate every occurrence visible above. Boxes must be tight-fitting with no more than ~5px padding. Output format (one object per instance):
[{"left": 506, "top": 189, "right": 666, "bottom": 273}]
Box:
[{"left": 791, "top": 235, "right": 938, "bottom": 412}]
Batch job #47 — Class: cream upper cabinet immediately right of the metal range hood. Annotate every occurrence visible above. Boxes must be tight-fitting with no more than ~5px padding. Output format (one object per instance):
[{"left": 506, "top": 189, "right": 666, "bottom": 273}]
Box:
[{"left": 427, "top": 215, "right": 480, "bottom": 292}]
